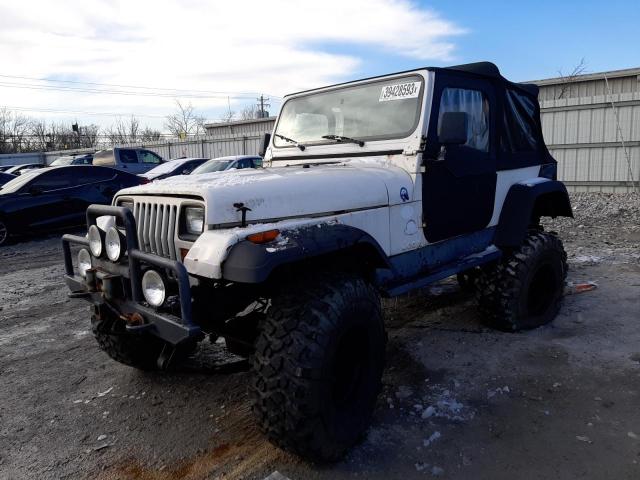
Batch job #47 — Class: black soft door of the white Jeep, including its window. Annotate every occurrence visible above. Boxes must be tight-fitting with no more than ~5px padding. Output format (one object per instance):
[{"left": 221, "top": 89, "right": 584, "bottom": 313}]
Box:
[{"left": 422, "top": 75, "right": 497, "bottom": 243}]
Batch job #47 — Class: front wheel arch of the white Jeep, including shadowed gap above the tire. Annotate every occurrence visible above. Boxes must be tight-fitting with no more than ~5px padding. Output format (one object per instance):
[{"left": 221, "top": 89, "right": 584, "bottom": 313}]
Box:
[{"left": 222, "top": 224, "right": 391, "bottom": 283}]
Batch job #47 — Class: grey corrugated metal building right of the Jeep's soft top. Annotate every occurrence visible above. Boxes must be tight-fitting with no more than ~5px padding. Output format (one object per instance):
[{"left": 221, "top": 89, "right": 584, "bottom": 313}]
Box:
[{"left": 530, "top": 68, "right": 640, "bottom": 192}]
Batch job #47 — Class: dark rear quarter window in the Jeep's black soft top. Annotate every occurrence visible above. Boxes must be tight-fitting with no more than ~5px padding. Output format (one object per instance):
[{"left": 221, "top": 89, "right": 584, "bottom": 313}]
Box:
[{"left": 500, "top": 89, "right": 539, "bottom": 153}]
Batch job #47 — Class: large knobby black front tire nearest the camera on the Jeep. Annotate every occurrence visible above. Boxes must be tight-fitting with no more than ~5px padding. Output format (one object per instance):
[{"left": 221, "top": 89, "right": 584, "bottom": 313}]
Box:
[{"left": 251, "top": 273, "right": 386, "bottom": 461}]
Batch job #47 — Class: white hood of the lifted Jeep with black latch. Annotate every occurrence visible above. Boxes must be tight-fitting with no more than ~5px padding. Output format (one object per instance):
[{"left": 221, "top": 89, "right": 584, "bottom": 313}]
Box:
[{"left": 118, "top": 163, "right": 413, "bottom": 225}]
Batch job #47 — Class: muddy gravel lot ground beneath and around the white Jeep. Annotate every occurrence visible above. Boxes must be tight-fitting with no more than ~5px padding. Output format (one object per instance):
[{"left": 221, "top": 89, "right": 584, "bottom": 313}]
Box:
[{"left": 0, "top": 194, "right": 640, "bottom": 480}]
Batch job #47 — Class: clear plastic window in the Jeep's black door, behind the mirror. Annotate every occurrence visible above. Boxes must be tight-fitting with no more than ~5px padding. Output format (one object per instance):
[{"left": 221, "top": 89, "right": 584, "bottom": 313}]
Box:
[{"left": 438, "top": 88, "right": 489, "bottom": 152}]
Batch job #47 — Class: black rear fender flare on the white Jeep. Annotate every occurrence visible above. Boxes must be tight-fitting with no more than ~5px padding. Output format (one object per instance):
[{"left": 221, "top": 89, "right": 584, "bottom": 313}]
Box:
[{"left": 495, "top": 179, "right": 573, "bottom": 247}]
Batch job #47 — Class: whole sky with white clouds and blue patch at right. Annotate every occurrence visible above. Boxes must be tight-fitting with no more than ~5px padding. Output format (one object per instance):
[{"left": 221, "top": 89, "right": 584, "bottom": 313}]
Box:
[{"left": 0, "top": 0, "right": 640, "bottom": 128}]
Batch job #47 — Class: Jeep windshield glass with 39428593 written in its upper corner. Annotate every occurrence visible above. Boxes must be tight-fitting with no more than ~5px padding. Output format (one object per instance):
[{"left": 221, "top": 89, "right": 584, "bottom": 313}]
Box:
[{"left": 274, "top": 75, "right": 423, "bottom": 147}]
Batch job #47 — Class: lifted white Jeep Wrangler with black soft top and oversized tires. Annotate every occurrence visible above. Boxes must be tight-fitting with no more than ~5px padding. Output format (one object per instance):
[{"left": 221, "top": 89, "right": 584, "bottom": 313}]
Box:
[{"left": 63, "top": 63, "right": 572, "bottom": 460}]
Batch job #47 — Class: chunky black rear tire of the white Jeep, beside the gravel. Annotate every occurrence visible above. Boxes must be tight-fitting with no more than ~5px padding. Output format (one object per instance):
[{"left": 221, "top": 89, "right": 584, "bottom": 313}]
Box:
[{"left": 477, "top": 231, "right": 567, "bottom": 332}]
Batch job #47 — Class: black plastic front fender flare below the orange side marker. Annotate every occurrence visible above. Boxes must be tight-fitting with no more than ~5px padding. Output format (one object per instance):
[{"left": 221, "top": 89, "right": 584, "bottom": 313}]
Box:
[{"left": 222, "top": 224, "right": 390, "bottom": 283}]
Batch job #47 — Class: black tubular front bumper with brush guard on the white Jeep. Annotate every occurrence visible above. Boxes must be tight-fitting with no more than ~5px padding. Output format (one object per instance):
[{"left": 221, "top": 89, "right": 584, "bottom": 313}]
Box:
[{"left": 62, "top": 205, "right": 202, "bottom": 345}]
